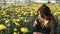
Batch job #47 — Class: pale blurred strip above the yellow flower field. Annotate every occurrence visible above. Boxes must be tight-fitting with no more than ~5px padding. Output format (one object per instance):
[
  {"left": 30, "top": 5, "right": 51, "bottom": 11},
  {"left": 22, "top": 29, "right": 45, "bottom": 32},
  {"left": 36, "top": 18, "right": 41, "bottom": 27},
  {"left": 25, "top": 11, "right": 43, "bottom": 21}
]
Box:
[{"left": 0, "top": 0, "right": 60, "bottom": 6}]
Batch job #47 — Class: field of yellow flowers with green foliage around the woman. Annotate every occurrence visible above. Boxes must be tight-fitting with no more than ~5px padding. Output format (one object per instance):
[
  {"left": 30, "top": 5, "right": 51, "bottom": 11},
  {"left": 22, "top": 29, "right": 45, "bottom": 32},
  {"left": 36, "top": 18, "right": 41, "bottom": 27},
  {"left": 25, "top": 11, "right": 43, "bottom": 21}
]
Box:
[{"left": 0, "top": 3, "right": 60, "bottom": 34}]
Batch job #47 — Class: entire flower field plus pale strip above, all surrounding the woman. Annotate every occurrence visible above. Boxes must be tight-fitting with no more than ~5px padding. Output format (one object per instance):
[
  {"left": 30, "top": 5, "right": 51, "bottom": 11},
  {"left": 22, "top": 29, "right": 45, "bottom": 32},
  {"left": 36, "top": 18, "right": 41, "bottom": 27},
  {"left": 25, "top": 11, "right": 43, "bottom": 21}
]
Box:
[{"left": 0, "top": 0, "right": 60, "bottom": 34}]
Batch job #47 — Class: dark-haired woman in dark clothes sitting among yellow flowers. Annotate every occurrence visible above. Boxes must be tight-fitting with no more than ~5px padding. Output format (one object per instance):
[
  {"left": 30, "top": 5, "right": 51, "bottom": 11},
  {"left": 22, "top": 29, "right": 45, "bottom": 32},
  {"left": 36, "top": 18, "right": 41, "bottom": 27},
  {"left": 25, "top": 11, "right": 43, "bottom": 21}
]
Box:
[{"left": 33, "top": 4, "right": 57, "bottom": 34}]
